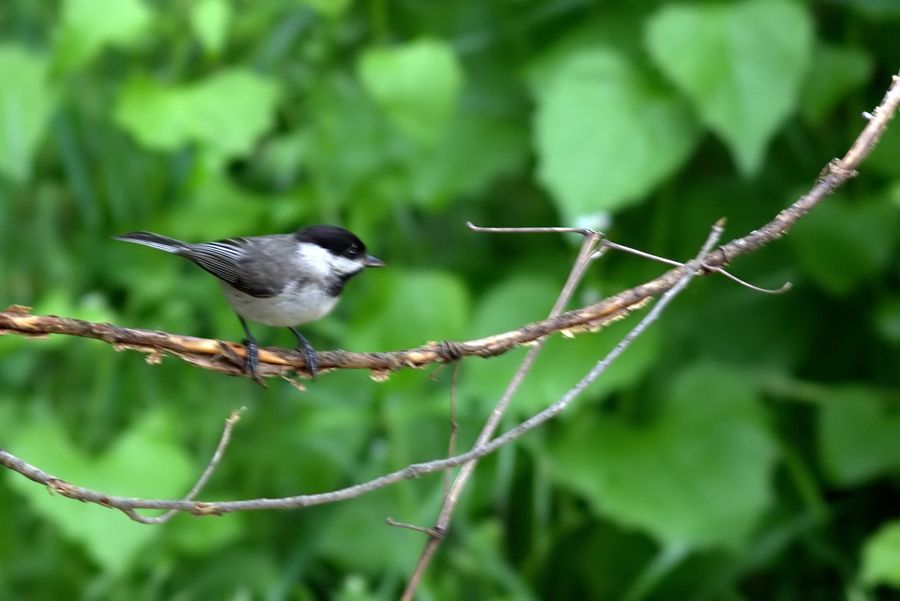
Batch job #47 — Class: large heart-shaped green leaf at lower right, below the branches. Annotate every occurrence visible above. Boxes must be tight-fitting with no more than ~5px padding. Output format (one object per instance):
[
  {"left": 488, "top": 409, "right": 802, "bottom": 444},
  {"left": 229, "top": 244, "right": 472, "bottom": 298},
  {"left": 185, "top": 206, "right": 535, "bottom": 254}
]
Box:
[{"left": 551, "top": 365, "right": 776, "bottom": 548}]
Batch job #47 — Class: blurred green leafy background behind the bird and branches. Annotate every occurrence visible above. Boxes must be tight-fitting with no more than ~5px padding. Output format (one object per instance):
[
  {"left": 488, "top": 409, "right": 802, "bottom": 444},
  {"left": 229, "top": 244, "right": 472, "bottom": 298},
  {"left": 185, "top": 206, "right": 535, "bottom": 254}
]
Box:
[{"left": 0, "top": 0, "right": 900, "bottom": 599}]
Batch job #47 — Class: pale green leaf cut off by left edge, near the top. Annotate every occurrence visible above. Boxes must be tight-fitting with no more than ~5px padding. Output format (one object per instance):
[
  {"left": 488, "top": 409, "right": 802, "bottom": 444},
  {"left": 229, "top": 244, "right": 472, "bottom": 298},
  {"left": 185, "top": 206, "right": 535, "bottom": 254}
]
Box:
[{"left": 0, "top": 45, "right": 57, "bottom": 183}]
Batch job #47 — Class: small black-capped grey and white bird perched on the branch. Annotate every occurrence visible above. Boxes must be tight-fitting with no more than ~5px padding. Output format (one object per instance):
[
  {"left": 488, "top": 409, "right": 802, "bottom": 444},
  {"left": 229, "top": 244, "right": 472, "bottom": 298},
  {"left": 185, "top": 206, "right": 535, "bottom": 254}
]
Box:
[{"left": 115, "top": 225, "right": 385, "bottom": 381}]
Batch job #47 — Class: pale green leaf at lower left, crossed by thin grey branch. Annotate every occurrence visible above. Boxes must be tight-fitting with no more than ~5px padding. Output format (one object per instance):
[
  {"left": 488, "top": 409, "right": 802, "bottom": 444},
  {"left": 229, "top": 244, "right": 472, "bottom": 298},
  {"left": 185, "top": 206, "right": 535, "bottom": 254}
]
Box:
[{"left": 9, "top": 413, "right": 193, "bottom": 573}]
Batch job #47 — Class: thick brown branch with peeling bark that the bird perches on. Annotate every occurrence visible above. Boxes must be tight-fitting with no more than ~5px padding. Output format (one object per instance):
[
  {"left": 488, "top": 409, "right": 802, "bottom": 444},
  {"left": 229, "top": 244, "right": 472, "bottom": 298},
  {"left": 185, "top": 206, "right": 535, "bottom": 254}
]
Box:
[{"left": 0, "top": 67, "right": 900, "bottom": 377}]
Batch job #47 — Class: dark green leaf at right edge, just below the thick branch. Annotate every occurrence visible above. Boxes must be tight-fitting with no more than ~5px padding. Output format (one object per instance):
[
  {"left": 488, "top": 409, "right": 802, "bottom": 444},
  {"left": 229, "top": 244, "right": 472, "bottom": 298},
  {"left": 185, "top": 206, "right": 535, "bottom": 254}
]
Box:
[{"left": 789, "top": 198, "right": 898, "bottom": 296}]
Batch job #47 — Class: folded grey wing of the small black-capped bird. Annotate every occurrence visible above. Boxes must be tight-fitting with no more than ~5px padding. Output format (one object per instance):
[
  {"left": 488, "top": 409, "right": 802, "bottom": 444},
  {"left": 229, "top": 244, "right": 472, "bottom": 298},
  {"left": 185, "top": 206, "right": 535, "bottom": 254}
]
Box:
[{"left": 178, "top": 238, "right": 282, "bottom": 298}]
